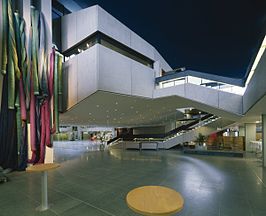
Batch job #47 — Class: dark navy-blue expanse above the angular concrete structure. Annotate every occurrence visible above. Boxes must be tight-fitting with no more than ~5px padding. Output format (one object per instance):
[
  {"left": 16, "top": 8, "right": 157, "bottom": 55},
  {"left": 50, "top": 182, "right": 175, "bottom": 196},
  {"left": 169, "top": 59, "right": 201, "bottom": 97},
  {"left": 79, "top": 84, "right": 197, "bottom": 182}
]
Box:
[{"left": 71, "top": 0, "right": 266, "bottom": 78}]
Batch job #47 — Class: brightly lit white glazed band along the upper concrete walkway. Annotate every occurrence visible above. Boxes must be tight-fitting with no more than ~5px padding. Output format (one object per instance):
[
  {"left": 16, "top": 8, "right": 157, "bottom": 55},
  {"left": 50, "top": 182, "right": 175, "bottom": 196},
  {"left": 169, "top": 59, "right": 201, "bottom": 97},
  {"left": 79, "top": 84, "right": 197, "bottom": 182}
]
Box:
[{"left": 158, "top": 76, "right": 246, "bottom": 95}]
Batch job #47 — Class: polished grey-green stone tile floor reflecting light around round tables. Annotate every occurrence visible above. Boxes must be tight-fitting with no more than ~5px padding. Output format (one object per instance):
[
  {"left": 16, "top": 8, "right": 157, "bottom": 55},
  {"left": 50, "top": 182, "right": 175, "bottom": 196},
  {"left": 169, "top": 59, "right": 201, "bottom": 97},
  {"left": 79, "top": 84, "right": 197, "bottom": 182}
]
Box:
[{"left": 0, "top": 143, "right": 266, "bottom": 216}]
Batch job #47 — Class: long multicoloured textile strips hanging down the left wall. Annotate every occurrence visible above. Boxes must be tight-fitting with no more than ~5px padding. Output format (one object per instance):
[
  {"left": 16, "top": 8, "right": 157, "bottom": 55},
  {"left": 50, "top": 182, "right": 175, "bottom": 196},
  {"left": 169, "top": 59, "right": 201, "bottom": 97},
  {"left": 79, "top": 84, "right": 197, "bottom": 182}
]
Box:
[{"left": 0, "top": 0, "right": 63, "bottom": 170}]
